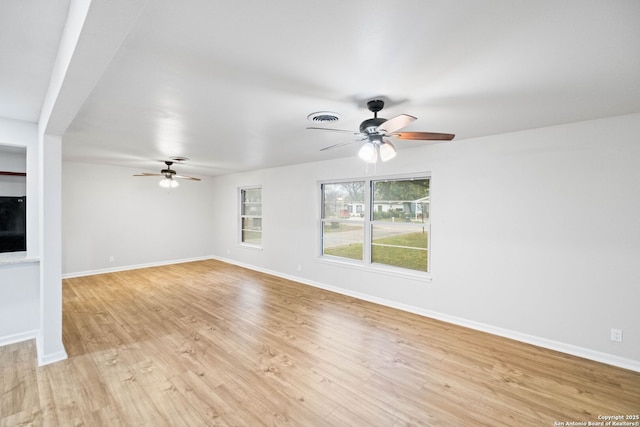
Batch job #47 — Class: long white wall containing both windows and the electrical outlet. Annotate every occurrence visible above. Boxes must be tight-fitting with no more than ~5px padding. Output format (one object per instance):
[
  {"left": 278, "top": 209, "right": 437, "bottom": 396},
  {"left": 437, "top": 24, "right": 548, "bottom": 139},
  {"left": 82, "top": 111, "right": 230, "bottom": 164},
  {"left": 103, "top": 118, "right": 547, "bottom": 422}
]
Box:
[{"left": 212, "top": 114, "right": 640, "bottom": 369}]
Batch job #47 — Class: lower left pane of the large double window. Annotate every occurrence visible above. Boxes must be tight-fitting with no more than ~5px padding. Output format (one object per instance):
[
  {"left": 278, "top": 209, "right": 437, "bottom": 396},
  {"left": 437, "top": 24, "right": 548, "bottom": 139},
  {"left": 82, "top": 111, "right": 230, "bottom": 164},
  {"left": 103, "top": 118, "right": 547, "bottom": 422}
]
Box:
[{"left": 322, "top": 221, "right": 364, "bottom": 260}]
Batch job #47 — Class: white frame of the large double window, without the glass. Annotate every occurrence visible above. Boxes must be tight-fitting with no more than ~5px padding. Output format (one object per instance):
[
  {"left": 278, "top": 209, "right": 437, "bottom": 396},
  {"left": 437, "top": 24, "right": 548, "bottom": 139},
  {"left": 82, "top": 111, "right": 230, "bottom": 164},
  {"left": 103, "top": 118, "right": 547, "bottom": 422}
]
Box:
[{"left": 317, "top": 172, "right": 433, "bottom": 282}]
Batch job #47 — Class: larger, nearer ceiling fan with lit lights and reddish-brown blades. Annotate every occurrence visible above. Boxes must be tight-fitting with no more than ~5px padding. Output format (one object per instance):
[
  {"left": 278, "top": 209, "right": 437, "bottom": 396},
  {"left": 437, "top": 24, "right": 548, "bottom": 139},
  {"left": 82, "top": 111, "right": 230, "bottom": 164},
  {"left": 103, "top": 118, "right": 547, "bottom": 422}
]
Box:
[{"left": 307, "top": 99, "right": 455, "bottom": 163}]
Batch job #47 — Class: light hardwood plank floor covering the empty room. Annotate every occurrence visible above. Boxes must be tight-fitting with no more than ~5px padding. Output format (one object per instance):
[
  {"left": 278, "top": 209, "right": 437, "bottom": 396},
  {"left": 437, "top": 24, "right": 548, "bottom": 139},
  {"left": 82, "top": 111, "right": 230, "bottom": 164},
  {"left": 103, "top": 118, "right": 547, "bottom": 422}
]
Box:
[{"left": 0, "top": 261, "right": 640, "bottom": 426}]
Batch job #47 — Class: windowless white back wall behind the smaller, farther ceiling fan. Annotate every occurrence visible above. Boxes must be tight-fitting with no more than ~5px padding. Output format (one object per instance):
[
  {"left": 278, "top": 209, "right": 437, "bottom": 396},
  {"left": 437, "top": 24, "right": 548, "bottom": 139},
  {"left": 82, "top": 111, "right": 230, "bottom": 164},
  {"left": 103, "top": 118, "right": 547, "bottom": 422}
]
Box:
[{"left": 62, "top": 162, "right": 218, "bottom": 277}]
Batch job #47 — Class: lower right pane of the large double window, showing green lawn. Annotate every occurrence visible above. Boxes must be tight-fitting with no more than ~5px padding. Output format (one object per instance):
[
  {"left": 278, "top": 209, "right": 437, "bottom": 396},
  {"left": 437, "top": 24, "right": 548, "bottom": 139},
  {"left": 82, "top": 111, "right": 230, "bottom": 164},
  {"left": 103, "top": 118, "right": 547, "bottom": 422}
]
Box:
[{"left": 371, "top": 222, "right": 429, "bottom": 271}]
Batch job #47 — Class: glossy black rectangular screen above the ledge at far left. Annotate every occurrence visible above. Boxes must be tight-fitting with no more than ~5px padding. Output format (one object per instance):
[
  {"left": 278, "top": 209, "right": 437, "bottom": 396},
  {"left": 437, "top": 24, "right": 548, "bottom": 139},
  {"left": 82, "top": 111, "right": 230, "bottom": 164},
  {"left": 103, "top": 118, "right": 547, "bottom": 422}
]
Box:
[{"left": 0, "top": 196, "right": 27, "bottom": 252}]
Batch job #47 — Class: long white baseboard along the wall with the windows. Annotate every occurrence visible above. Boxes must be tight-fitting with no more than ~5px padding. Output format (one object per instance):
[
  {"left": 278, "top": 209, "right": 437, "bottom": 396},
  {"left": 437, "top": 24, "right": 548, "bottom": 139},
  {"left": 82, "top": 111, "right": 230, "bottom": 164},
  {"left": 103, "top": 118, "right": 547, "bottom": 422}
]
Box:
[{"left": 211, "top": 256, "right": 640, "bottom": 372}]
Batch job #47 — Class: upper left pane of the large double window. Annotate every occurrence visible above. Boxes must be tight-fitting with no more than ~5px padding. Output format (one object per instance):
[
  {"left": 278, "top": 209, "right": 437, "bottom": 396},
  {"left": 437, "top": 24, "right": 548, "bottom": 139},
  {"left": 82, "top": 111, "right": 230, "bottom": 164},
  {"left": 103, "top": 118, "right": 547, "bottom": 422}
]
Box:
[{"left": 322, "top": 181, "right": 366, "bottom": 219}]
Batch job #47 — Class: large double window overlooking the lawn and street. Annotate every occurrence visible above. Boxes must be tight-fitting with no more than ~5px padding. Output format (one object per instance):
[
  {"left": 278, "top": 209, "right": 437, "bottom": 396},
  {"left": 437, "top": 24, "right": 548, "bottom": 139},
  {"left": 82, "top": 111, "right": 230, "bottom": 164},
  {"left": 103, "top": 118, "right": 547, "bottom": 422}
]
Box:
[{"left": 322, "top": 177, "right": 429, "bottom": 272}]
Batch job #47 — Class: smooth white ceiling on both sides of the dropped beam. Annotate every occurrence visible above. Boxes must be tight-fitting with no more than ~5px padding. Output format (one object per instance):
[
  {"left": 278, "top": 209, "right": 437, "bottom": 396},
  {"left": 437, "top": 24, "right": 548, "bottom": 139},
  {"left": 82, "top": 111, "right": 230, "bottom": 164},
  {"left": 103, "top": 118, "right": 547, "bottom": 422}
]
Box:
[{"left": 0, "top": 0, "right": 640, "bottom": 176}]
